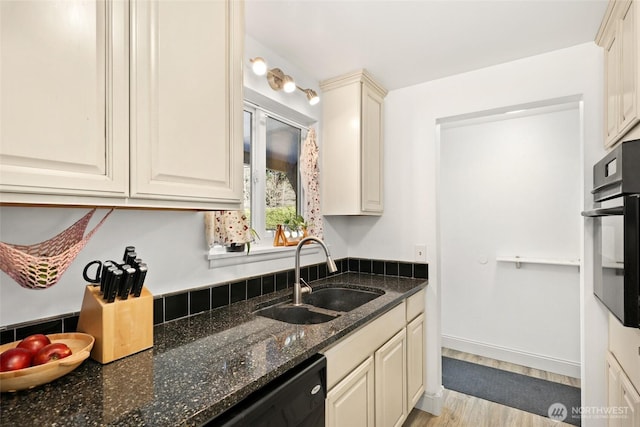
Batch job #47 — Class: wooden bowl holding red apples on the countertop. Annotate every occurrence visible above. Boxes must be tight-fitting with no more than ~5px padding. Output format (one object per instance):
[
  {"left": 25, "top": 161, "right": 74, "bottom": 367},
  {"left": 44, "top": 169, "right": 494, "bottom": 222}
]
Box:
[{"left": 0, "top": 333, "right": 95, "bottom": 392}]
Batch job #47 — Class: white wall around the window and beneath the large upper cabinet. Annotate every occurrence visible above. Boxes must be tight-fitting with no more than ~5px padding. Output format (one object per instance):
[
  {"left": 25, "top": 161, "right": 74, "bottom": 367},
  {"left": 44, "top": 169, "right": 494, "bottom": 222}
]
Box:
[{"left": 0, "top": 35, "right": 347, "bottom": 327}]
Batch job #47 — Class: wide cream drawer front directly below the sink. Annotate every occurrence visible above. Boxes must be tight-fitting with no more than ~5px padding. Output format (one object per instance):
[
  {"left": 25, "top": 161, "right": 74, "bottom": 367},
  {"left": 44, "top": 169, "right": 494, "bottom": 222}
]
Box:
[{"left": 321, "top": 301, "right": 406, "bottom": 390}]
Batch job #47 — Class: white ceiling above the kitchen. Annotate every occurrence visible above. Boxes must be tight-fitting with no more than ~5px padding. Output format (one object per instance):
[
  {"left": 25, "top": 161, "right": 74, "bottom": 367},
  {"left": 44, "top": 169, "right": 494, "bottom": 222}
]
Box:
[{"left": 245, "top": 0, "right": 607, "bottom": 90}]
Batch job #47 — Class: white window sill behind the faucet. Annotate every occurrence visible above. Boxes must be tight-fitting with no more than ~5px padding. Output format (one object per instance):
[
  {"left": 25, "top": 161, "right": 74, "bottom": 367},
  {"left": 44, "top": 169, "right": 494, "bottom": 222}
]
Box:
[{"left": 207, "top": 245, "right": 321, "bottom": 269}]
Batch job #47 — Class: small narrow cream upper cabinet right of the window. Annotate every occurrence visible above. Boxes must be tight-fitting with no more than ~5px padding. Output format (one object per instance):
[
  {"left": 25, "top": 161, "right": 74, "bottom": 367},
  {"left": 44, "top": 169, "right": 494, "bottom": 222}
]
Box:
[{"left": 320, "top": 70, "right": 387, "bottom": 215}]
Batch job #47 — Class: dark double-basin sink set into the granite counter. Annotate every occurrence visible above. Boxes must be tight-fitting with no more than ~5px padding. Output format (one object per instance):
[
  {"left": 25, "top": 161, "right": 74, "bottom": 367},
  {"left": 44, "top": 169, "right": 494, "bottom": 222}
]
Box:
[{"left": 255, "top": 285, "right": 384, "bottom": 325}]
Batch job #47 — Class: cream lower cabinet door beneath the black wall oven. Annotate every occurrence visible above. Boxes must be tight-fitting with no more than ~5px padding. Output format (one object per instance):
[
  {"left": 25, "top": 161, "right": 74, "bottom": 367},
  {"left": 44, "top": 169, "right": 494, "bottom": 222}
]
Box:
[{"left": 606, "top": 353, "right": 640, "bottom": 427}]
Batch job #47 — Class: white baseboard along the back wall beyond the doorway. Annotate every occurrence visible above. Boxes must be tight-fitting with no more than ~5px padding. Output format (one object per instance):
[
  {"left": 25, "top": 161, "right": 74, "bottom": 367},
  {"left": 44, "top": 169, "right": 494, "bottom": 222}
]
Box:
[{"left": 442, "top": 335, "right": 580, "bottom": 378}]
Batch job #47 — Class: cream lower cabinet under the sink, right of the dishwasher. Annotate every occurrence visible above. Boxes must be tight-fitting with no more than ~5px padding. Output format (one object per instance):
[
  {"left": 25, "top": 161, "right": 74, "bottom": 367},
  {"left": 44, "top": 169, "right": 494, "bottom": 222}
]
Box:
[{"left": 322, "top": 290, "right": 425, "bottom": 427}]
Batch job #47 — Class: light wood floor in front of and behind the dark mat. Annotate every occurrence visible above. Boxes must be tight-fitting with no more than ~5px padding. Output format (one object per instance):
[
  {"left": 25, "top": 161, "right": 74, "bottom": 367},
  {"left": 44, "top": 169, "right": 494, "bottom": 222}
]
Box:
[{"left": 403, "top": 348, "right": 580, "bottom": 427}]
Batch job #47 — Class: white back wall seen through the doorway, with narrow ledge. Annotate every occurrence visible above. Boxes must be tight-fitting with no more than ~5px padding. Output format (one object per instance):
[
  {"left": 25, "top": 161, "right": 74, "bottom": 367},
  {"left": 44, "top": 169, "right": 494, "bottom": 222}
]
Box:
[{"left": 439, "top": 101, "right": 582, "bottom": 377}]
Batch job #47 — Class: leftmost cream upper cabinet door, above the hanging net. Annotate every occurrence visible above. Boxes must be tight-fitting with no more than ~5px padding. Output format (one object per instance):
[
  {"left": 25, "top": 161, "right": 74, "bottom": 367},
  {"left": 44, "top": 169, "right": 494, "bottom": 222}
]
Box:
[{"left": 0, "top": 0, "right": 129, "bottom": 199}]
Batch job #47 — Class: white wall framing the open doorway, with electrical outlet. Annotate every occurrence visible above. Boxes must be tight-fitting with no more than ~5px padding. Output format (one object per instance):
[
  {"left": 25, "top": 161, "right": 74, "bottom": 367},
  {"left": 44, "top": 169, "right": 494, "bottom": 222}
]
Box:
[{"left": 349, "top": 43, "right": 607, "bottom": 425}]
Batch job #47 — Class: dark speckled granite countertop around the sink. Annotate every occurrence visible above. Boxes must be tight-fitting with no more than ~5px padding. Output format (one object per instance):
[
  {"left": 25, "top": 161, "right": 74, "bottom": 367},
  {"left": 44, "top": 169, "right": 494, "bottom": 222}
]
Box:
[{"left": 0, "top": 273, "right": 427, "bottom": 426}]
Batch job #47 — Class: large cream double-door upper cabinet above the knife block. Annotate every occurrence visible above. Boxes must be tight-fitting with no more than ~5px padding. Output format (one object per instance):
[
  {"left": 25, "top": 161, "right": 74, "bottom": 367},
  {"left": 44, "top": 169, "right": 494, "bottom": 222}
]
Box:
[{"left": 0, "top": 0, "right": 244, "bottom": 209}]
